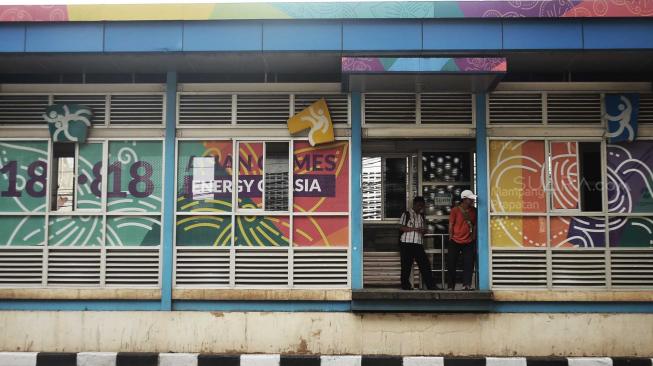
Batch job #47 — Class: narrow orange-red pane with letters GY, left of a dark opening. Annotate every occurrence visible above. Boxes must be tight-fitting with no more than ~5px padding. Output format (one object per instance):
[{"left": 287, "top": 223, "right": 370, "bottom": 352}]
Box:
[{"left": 238, "top": 142, "right": 264, "bottom": 209}]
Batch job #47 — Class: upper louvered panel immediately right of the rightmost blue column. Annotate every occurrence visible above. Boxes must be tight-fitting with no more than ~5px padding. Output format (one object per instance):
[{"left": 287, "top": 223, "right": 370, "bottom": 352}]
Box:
[{"left": 489, "top": 93, "right": 542, "bottom": 124}]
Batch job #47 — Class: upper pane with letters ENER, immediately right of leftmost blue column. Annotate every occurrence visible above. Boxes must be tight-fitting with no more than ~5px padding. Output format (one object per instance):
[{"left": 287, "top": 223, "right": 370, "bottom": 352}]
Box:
[{"left": 177, "top": 141, "right": 233, "bottom": 212}]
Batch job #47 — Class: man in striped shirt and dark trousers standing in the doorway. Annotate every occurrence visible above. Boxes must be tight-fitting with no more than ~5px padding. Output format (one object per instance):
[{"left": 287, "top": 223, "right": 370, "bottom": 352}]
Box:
[{"left": 399, "top": 196, "right": 435, "bottom": 290}]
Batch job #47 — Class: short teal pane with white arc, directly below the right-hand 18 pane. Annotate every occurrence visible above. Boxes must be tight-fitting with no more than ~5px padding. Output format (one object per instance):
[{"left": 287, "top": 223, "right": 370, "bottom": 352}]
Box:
[{"left": 106, "top": 216, "right": 161, "bottom": 247}]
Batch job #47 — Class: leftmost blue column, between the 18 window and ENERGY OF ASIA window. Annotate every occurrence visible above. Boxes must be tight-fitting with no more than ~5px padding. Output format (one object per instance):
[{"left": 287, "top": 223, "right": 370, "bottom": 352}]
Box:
[{"left": 161, "top": 71, "right": 177, "bottom": 311}]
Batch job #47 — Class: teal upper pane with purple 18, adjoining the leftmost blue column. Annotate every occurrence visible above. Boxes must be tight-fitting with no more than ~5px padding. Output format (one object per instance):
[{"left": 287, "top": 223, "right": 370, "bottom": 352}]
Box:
[{"left": 107, "top": 141, "right": 163, "bottom": 213}]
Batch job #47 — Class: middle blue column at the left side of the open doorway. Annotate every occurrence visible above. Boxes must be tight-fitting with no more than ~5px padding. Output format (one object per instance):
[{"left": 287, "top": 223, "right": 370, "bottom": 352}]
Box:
[{"left": 351, "top": 92, "right": 363, "bottom": 289}]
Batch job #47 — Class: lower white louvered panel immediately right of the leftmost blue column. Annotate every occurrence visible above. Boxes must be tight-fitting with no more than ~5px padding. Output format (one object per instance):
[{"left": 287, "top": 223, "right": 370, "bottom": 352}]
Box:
[{"left": 175, "top": 248, "right": 229, "bottom": 287}]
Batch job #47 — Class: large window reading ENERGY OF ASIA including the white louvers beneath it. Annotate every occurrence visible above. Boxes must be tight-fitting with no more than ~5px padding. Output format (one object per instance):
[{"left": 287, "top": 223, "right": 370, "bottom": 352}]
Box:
[{"left": 175, "top": 139, "right": 350, "bottom": 288}]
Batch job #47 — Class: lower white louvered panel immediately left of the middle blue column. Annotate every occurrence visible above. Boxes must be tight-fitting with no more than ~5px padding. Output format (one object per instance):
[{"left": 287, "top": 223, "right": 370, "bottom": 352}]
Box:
[{"left": 293, "top": 248, "right": 347, "bottom": 287}]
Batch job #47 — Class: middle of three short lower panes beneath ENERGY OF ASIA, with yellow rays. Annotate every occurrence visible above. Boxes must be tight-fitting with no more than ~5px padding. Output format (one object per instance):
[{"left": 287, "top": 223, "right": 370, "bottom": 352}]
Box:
[{"left": 234, "top": 216, "right": 290, "bottom": 247}]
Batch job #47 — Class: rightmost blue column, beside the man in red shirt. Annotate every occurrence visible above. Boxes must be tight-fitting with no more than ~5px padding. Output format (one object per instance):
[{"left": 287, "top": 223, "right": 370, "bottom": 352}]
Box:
[{"left": 476, "top": 94, "right": 490, "bottom": 291}]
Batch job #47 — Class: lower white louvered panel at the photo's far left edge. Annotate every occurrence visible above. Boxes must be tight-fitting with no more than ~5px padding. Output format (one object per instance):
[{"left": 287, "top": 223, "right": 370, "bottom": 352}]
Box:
[{"left": 0, "top": 248, "right": 43, "bottom": 287}]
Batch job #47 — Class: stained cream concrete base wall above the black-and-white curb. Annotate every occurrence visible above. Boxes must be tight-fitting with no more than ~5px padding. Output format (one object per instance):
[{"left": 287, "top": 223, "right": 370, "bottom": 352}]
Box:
[{"left": 0, "top": 311, "right": 653, "bottom": 357}]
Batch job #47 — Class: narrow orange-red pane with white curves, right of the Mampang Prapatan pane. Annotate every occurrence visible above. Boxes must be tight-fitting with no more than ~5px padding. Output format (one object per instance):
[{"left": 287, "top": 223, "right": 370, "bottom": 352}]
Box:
[{"left": 550, "top": 141, "right": 580, "bottom": 210}]
